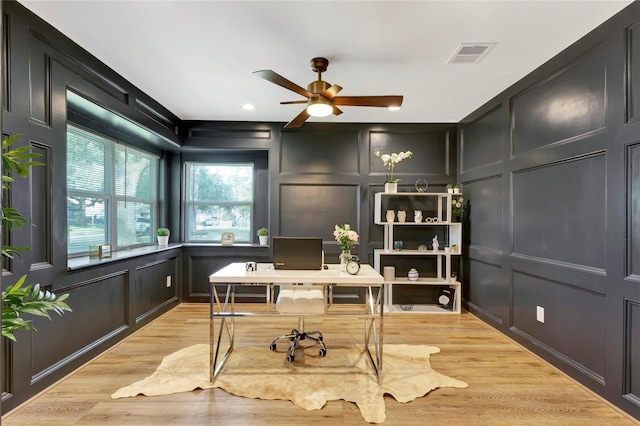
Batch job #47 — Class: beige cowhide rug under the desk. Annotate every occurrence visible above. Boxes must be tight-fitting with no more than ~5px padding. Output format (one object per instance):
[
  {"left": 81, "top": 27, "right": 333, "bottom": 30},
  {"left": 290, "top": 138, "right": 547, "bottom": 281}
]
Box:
[{"left": 111, "top": 344, "right": 467, "bottom": 423}]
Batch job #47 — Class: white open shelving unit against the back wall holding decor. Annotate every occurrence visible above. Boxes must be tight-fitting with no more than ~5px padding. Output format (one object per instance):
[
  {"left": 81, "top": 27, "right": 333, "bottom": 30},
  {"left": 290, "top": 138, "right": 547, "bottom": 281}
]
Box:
[{"left": 373, "top": 192, "right": 462, "bottom": 314}]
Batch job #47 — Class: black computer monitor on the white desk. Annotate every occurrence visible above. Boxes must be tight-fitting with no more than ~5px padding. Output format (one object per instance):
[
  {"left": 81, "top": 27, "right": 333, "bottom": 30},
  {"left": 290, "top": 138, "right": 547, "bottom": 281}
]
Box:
[{"left": 272, "top": 237, "right": 324, "bottom": 270}]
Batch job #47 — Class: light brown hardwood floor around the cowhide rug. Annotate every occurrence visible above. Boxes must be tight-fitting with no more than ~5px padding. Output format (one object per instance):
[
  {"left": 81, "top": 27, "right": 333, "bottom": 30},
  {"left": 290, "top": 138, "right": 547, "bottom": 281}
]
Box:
[{"left": 2, "top": 304, "right": 638, "bottom": 426}]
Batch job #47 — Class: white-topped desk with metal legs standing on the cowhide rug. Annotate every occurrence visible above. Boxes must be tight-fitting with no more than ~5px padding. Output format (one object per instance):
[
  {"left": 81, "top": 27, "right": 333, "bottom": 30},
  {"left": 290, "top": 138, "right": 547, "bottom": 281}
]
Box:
[{"left": 209, "top": 262, "right": 384, "bottom": 382}]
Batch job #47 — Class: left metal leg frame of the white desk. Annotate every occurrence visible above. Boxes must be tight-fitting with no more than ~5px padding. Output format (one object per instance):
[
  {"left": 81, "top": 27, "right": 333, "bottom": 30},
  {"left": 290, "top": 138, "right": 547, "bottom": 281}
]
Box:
[{"left": 209, "top": 284, "right": 235, "bottom": 383}]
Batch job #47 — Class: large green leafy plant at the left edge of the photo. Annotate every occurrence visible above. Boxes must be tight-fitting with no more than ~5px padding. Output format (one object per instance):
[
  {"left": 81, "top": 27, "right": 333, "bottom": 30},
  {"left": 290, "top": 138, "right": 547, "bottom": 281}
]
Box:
[{"left": 2, "top": 135, "right": 71, "bottom": 341}]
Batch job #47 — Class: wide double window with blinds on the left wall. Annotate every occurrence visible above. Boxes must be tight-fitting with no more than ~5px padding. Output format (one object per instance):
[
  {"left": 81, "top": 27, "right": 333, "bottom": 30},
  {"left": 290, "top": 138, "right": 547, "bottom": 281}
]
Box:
[{"left": 67, "top": 123, "right": 159, "bottom": 255}]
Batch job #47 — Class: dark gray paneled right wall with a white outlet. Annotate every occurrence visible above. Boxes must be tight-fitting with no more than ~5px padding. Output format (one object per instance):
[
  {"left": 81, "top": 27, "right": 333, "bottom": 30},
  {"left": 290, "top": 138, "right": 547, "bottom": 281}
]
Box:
[{"left": 458, "top": 3, "right": 640, "bottom": 418}]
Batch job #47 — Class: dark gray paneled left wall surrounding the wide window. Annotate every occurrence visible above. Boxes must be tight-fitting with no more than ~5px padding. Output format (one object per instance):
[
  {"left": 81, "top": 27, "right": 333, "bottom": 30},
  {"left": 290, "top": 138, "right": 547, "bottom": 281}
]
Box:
[{"left": 0, "top": 1, "right": 182, "bottom": 413}]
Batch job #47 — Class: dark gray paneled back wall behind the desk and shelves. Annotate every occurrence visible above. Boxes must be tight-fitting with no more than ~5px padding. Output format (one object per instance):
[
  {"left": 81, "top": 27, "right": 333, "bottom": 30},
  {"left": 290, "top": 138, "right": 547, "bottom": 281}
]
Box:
[{"left": 176, "top": 121, "right": 457, "bottom": 303}]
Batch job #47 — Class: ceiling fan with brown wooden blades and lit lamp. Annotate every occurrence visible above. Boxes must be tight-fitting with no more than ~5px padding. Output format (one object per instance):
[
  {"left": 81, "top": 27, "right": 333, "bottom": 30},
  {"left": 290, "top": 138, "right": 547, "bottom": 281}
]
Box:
[{"left": 254, "top": 58, "right": 402, "bottom": 129}]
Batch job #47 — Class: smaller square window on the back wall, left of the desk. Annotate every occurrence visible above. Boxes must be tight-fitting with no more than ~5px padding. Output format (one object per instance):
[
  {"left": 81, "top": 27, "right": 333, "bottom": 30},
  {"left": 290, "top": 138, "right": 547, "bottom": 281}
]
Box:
[{"left": 185, "top": 162, "right": 254, "bottom": 243}]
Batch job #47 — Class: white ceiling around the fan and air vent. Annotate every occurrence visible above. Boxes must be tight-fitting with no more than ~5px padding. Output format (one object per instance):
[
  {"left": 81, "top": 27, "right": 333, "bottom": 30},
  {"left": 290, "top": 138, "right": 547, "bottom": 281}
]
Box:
[{"left": 20, "top": 0, "right": 632, "bottom": 123}]
